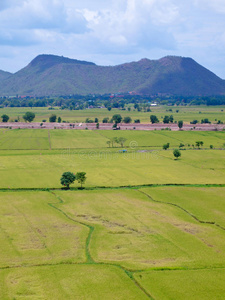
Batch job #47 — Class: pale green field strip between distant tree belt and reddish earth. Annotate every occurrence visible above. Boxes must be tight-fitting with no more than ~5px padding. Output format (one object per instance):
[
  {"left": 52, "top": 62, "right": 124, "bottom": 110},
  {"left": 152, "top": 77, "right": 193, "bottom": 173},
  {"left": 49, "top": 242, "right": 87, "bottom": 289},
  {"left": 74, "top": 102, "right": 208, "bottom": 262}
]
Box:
[{"left": 0, "top": 106, "right": 225, "bottom": 123}]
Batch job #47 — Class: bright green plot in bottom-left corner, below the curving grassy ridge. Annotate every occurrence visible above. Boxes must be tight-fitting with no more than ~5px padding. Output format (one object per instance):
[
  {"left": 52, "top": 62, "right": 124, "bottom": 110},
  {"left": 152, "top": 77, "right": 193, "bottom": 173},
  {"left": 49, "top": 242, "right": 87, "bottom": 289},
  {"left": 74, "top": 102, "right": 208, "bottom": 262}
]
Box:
[{"left": 0, "top": 265, "right": 148, "bottom": 300}]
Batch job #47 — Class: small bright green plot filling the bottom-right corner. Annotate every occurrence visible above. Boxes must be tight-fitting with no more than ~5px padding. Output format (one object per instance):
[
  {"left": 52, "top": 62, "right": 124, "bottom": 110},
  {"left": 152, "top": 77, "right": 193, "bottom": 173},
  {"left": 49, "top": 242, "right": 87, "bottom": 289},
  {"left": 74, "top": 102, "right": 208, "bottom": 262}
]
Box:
[{"left": 135, "top": 268, "right": 225, "bottom": 300}]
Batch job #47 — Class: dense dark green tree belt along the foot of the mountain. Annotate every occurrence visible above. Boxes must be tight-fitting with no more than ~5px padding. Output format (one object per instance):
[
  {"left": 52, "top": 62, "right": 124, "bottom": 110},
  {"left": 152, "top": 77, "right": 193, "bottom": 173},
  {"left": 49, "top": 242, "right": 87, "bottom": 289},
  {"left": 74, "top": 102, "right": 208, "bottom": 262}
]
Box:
[{"left": 0, "top": 94, "right": 225, "bottom": 112}]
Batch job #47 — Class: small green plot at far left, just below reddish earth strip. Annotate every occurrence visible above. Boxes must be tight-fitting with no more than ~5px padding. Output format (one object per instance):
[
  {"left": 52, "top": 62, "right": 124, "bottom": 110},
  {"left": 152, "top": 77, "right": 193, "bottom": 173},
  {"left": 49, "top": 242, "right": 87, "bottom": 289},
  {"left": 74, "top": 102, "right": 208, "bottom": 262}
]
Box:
[{"left": 0, "top": 129, "right": 49, "bottom": 150}]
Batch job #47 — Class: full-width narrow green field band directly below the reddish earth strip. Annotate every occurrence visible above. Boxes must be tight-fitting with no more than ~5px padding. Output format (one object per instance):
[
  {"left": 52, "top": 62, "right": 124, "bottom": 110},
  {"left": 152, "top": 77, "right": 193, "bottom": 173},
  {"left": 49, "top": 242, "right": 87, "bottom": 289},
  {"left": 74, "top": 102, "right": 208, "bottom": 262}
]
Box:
[{"left": 0, "top": 129, "right": 225, "bottom": 150}]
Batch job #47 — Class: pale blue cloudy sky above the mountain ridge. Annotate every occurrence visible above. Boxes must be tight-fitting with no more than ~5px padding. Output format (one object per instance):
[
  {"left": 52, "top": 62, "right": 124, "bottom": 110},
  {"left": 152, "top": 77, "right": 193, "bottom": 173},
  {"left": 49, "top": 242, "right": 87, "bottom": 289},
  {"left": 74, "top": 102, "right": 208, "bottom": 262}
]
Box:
[{"left": 0, "top": 0, "right": 225, "bottom": 79}]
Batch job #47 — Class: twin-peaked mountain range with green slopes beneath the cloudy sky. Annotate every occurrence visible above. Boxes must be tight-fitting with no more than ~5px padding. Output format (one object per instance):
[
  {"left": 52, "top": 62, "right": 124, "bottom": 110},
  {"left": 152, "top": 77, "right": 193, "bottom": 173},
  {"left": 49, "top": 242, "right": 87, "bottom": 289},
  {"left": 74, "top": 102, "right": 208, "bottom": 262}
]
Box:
[{"left": 0, "top": 54, "right": 225, "bottom": 96}]
